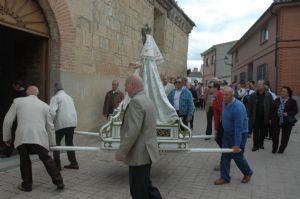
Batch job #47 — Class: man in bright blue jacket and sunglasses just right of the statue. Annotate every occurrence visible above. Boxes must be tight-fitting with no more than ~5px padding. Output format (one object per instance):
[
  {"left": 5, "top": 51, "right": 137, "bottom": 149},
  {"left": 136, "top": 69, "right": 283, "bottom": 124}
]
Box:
[{"left": 168, "top": 78, "right": 195, "bottom": 126}]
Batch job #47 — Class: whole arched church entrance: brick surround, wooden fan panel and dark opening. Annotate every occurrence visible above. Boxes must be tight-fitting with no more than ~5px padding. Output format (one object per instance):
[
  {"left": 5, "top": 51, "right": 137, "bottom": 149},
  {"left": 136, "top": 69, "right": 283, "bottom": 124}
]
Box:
[{"left": 0, "top": 0, "right": 75, "bottom": 145}]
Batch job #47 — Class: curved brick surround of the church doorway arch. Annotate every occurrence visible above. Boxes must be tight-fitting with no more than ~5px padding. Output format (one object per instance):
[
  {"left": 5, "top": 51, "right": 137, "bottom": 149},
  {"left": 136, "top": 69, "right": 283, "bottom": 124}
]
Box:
[{"left": 38, "top": 0, "right": 76, "bottom": 98}]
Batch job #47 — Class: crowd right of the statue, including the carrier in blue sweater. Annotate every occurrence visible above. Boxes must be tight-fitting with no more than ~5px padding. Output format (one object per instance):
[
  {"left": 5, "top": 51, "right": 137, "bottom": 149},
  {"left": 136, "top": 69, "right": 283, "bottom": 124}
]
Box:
[{"left": 159, "top": 77, "right": 298, "bottom": 185}]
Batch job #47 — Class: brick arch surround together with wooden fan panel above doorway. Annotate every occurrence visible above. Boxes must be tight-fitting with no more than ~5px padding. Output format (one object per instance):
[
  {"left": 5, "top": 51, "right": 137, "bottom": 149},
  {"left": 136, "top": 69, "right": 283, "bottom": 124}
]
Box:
[{"left": 0, "top": 0, "right": 76, "bottom": 100}]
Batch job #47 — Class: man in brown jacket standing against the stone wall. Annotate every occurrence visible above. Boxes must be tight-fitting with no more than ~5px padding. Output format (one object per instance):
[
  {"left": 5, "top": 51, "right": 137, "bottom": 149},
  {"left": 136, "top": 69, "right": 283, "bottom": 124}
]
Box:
[{"left": 102, "top": 80, "right": 124, "bottom": 118}]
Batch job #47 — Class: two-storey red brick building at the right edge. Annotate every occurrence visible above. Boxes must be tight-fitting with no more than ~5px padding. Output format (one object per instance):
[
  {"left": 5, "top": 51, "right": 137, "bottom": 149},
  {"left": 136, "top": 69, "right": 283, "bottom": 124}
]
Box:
[{"left": 229, "top": 0, "right": 300, "bottom": 96}]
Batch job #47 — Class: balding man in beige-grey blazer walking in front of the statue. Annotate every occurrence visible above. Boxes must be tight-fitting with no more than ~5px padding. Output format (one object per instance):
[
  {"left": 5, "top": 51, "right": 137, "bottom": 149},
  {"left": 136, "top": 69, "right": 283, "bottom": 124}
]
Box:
[{"left": 115, "top": 76, "right": 162, "bottom": 199}]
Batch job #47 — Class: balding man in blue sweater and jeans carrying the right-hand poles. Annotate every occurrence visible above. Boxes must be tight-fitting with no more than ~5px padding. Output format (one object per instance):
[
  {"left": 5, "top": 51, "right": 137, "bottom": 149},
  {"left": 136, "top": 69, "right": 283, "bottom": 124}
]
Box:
[{"left": 215, "top": 86, "right": 253, "bottom": 185}]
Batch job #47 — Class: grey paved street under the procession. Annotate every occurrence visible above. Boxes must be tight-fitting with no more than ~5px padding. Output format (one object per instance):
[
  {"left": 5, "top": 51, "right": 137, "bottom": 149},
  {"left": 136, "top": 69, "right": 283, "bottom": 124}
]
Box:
[{"left": 0, "top": 111, "right": 300, "bottom": 199}]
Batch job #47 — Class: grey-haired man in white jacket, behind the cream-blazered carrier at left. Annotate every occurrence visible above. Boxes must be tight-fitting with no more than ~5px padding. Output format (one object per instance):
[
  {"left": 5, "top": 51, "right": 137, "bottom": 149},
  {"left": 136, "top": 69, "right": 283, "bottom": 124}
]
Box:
[{"left": 50, "top": 82, "right": 79, "bottom": 170}]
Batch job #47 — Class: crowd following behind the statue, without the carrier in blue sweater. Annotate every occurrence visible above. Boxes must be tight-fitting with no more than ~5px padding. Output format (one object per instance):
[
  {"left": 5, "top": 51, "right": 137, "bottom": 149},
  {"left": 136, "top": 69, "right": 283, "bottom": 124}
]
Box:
[{"left": 159, "top": 77, "right": 298, "bottom": 153}]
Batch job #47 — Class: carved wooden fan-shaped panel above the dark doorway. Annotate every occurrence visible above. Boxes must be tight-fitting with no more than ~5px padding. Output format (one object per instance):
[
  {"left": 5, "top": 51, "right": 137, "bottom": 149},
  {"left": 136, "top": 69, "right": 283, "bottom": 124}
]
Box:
[{"left": 0, "top": 0, "right": 49, "bottom": 38}]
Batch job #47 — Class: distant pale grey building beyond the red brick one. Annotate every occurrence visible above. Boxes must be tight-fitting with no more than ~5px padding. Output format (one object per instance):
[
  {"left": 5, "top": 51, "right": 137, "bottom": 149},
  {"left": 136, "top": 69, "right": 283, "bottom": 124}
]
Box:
[{"left": 201, "top": 41, "right": 236, "bottom": 85}]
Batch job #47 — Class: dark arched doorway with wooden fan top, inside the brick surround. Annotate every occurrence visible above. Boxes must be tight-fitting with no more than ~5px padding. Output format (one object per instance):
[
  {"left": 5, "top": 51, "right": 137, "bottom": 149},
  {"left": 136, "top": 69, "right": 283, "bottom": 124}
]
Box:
[{"left": 0, "top": 0, "right": 49, "bottom": 145}]
